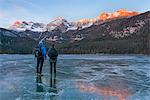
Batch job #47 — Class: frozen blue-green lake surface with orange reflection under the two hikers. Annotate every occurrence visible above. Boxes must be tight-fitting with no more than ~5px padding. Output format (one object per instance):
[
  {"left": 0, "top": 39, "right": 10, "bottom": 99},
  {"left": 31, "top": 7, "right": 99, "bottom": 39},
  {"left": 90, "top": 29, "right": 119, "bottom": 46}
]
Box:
[{"left": 0, "top": 54, "right": 150, "bottom": 100}]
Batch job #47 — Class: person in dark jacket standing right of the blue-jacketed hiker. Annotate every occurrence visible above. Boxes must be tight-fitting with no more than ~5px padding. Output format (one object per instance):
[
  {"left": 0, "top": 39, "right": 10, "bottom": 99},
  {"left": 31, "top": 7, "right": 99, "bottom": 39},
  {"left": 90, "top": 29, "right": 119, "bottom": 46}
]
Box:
[{"left": 48, "top": 44, "right": 58, "bottom": 76}]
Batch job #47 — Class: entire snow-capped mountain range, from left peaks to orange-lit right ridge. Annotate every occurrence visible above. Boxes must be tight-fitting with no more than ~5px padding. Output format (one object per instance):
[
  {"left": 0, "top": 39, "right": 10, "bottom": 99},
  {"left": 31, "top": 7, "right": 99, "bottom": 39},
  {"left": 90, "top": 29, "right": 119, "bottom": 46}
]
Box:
[{"left": 10, "top": 9, "right": 140, "bottom": 32}]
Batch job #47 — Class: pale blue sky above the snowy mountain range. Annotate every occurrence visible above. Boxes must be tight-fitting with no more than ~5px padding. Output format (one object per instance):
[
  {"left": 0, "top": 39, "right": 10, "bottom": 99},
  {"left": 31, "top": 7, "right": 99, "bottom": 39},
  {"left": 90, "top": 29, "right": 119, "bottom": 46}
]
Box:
[{"left": 0, "top": 0, "right": 150, "bottom": 27}]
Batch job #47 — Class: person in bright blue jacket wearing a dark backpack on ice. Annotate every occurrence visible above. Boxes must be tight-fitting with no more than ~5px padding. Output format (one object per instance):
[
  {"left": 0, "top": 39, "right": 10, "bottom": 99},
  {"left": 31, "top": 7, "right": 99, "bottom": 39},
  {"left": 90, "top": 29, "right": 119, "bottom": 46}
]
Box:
[{"left": 35, "top": 39, "right": 46, "bottom": 75}]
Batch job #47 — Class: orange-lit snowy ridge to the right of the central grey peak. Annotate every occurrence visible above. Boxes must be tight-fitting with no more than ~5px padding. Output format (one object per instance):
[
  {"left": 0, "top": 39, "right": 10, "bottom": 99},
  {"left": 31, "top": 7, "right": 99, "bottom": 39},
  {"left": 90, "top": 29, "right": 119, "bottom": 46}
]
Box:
[{"left": 69, "top": 9, "right": 140, "bottom": 29}]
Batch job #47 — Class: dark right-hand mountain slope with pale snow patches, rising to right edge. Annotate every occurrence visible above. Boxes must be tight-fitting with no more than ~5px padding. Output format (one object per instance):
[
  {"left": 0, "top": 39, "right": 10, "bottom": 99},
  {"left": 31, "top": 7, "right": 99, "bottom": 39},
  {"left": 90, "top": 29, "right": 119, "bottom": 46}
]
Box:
[{"left": 61, "top": 11, "right": 150, "bottom": 54}]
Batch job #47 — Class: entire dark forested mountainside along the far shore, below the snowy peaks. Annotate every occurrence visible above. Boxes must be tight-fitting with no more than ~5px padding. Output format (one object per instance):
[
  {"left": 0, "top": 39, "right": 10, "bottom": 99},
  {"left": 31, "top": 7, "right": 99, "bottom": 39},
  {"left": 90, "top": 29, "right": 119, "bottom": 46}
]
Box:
[{"left": 0, "top": 11, "right": 150, "bottom": 54}]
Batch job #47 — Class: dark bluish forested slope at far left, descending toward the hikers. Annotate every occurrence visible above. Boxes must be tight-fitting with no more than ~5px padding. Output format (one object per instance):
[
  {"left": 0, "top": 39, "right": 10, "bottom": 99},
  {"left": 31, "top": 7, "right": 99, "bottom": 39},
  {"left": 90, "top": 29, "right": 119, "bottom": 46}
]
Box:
[{"left": 0, "top": 28, "right": 37, "bottom": 53}]
